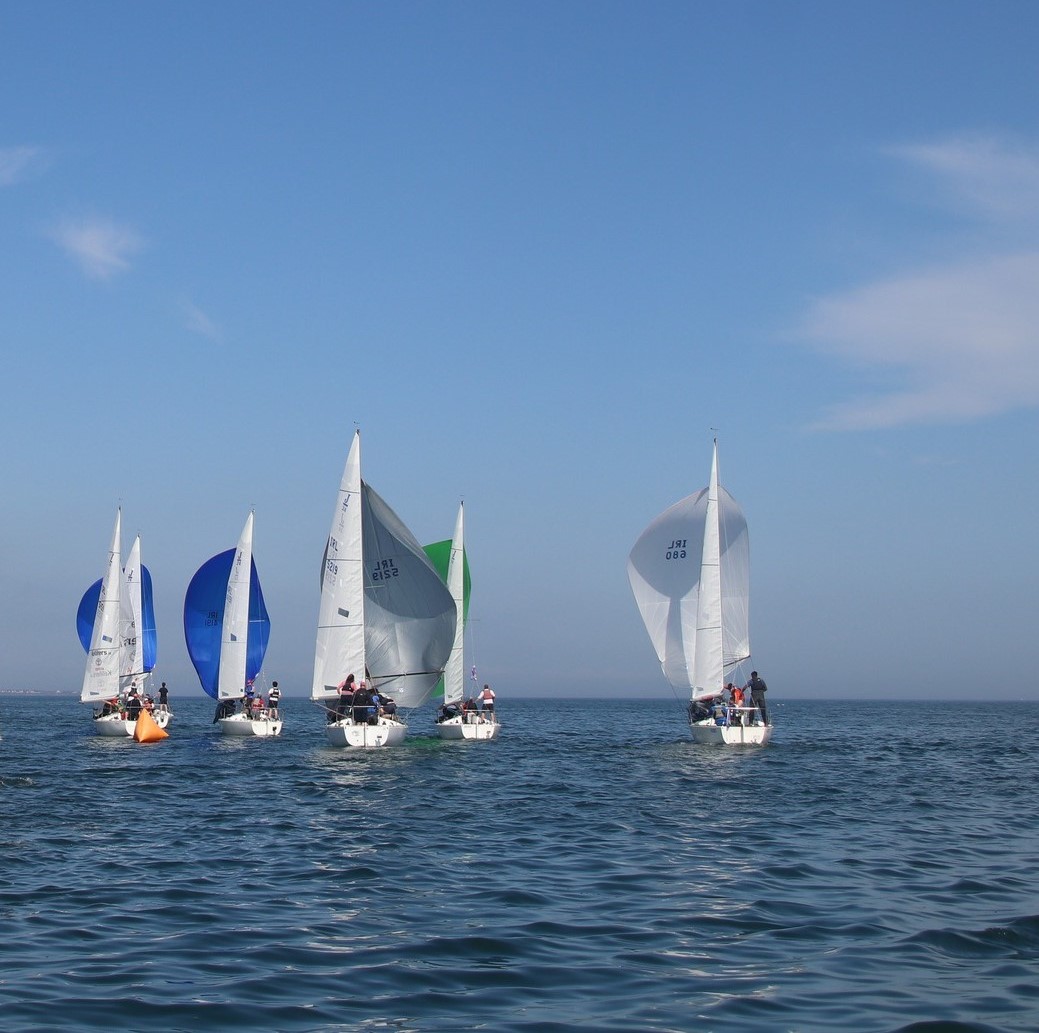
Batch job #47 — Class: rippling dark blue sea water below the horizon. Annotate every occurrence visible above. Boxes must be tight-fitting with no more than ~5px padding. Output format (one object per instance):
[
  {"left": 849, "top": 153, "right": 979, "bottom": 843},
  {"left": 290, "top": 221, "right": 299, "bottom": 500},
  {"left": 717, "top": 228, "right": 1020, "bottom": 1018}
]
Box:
[{"left": 0, "top": 693, "right": 1039, "bottom": 1033}]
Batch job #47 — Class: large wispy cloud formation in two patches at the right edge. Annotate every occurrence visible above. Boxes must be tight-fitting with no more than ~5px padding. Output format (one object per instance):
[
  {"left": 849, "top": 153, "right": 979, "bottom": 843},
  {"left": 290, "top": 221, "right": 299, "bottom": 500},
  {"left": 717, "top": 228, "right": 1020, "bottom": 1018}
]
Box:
[{"left": 799, "top": 139, "right": 1039, "bottom": 430}]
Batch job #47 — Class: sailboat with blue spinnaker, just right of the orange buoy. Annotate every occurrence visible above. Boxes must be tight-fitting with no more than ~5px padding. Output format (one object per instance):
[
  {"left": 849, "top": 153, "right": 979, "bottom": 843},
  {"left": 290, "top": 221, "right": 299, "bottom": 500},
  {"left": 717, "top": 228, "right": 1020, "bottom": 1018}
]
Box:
[{"left": 184, "top": 512, "right": 282, "bottom": 736}]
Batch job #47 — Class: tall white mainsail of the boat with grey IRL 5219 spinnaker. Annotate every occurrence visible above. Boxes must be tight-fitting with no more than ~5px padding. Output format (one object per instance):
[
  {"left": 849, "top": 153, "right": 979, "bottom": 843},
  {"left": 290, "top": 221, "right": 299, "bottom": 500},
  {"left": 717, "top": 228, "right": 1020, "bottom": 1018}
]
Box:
[{"left": 311, "top": 431, "right": 366, "bottom": 699}]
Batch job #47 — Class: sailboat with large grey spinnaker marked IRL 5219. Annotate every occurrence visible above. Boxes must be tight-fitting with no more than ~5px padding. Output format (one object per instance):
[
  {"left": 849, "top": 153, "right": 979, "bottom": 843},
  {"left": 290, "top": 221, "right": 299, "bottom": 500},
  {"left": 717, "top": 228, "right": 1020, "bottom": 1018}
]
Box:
[{"left": 311, "top": 431, "right": 455, "bottom": 748}]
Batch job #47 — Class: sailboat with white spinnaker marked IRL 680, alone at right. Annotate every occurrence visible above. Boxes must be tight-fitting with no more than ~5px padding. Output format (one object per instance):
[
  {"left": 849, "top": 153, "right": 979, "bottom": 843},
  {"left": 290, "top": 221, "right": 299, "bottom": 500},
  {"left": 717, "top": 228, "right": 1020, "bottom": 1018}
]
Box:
[{"left": 628, "top": 440, "right": 772, "bottom": 745}]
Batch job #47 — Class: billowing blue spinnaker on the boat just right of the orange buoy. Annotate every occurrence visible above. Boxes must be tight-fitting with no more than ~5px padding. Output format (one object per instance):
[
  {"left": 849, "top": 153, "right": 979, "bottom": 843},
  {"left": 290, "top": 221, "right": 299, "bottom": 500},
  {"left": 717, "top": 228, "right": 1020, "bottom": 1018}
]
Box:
[{"left": 184, "top": 549, "right": 270, "bottom": 699}]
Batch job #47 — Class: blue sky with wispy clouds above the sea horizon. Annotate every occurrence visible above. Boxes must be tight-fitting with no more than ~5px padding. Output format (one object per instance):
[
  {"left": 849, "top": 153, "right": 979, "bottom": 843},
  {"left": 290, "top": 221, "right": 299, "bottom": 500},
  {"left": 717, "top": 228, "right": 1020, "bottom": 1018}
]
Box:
[{"left": 0, "top": 2, "right": 1039, "bottom": 701}]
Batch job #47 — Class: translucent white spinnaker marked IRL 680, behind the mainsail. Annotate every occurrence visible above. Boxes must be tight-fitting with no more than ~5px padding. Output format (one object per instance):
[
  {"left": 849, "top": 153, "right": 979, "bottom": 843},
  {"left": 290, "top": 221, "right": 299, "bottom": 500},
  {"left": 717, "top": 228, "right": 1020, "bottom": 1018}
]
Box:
[{"left": 628, "top": 438, "right": 750, "bottom": 697}]
